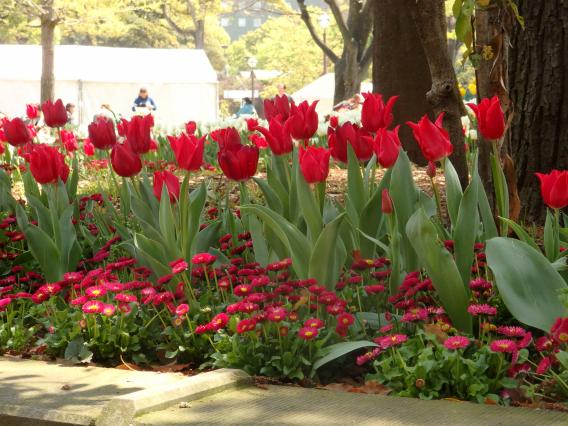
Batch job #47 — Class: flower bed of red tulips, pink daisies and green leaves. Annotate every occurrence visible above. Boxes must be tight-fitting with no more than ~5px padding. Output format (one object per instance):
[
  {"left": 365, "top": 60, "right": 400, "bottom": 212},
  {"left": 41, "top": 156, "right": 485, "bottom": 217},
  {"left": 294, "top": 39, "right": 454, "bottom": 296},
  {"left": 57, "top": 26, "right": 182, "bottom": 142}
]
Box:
[{"left": 0, "top": 94, "right": 568, "bottom": 403}]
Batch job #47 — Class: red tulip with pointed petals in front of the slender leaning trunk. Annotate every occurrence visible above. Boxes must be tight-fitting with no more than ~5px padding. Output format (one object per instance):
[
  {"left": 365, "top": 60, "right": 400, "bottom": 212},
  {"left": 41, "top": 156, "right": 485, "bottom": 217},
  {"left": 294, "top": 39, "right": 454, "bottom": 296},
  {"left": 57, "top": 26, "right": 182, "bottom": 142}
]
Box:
[{"left": 406, "top": 113, "right": 454, "bottom": 161}]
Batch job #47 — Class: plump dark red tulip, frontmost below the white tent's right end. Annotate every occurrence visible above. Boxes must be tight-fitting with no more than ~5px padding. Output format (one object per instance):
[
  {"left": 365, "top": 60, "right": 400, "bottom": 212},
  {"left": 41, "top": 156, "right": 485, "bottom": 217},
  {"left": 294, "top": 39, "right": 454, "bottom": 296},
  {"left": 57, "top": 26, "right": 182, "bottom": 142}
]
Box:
[{"left": 217, "top": 144, "right": 258, "bottom": 182}]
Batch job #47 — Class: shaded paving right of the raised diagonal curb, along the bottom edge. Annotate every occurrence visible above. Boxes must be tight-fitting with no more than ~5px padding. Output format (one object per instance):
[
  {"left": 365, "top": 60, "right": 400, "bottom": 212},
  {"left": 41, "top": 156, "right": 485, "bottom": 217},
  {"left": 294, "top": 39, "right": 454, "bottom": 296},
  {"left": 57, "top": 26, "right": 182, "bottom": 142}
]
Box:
[{"left": 136, "top": 386, "right": 568, "bottom": 426}]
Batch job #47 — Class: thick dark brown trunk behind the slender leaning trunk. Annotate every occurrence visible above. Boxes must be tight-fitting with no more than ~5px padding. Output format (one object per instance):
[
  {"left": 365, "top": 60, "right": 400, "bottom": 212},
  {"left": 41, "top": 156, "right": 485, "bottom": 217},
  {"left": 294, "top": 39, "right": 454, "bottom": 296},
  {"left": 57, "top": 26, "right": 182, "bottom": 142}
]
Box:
[{"left": 373, "top": 0, "right": 434, "bottom": 165}]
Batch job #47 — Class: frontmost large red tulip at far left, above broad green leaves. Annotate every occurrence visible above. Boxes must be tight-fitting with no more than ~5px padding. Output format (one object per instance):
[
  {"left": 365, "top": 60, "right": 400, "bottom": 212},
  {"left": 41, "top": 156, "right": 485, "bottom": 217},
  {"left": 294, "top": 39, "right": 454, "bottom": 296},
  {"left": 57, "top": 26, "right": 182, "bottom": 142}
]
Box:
[{"left": 30, "top": 144, "right": 69, "bottom": 185}]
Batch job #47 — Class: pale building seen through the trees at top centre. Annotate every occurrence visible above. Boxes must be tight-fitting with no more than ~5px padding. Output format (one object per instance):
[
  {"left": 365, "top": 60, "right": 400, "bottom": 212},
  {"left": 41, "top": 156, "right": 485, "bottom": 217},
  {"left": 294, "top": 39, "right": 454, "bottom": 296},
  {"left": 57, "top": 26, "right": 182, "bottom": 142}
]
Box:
[{"left": 219, "top": 0, "right": 327, "bottom": 41}]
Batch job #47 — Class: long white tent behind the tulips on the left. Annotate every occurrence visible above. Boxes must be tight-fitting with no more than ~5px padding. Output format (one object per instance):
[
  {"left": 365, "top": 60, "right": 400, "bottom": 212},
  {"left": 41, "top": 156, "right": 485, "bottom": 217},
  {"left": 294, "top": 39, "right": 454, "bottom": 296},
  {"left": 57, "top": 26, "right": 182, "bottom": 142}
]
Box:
[{"left": 0, "top": 45, "right": 218, "bottom": 127}]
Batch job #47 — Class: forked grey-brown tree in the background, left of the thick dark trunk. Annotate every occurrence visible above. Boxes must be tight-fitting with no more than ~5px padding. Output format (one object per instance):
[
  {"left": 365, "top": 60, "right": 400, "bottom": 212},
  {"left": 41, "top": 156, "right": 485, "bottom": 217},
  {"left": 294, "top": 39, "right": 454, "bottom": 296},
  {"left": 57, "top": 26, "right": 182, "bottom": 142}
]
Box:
[{"left": 297, "top": 0, "right": 376, "bottom": 103}]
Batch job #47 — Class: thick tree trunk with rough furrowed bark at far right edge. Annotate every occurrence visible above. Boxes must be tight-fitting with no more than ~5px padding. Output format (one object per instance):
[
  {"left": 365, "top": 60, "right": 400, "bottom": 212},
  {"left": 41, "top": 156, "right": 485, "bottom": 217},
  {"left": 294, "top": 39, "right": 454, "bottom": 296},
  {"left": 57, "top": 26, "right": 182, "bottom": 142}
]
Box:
[{"left": 509, "top": 0, "right": 568, "bottom": 221}]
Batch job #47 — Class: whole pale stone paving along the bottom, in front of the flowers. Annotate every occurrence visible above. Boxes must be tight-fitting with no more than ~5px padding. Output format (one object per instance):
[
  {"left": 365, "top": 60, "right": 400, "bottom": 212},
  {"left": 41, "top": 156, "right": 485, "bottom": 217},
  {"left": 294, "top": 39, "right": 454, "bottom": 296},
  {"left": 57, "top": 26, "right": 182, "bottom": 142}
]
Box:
[{"left": 0, "top": 357, "right": 568, "bottom": 426}]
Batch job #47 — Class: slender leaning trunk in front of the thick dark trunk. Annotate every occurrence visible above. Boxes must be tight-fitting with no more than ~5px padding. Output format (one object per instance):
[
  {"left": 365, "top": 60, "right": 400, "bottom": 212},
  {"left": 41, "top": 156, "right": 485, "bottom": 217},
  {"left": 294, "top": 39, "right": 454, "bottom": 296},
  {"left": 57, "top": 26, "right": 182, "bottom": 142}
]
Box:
[{"left": 409, "top": 0, "right": 469, "bottom": 188}]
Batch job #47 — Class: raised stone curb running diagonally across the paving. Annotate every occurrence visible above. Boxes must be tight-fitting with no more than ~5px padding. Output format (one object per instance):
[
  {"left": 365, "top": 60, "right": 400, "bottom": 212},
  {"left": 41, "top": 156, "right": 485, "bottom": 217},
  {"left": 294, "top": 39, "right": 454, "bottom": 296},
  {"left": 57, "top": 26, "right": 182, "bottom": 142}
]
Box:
[{"left": 96, "top": 368, "right": 251, "bottom": 426}]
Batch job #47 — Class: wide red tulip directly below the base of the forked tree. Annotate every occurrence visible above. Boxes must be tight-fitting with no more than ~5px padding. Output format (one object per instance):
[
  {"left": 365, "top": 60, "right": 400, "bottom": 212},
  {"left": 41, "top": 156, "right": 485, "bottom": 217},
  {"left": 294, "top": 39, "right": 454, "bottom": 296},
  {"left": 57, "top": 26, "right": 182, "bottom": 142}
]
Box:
[{"left": 327, "top": 121, "right": 373, "bottom": 163}]
